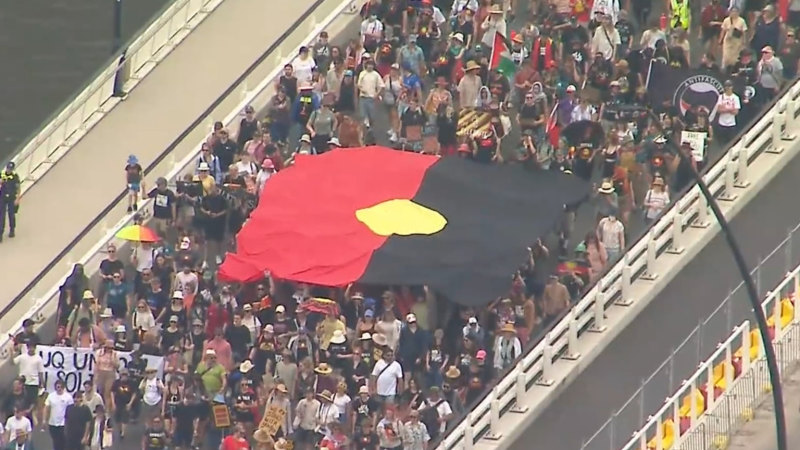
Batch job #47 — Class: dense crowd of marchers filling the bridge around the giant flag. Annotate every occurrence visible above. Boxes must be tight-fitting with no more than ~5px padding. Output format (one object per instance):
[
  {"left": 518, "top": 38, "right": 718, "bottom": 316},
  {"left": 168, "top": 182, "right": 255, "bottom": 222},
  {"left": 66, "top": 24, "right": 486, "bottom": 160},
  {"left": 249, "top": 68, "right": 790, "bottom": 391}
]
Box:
[{"left": 2, "top": 0, "right": 800, "bottom": 450}]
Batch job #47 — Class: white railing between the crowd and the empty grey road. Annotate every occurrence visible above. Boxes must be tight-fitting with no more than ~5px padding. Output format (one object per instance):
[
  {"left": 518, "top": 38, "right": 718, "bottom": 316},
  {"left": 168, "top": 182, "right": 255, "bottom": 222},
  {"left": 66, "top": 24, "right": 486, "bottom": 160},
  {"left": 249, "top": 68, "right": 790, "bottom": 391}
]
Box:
[{"left": 432, "top": 81, "right": 800, "bottom": 450}]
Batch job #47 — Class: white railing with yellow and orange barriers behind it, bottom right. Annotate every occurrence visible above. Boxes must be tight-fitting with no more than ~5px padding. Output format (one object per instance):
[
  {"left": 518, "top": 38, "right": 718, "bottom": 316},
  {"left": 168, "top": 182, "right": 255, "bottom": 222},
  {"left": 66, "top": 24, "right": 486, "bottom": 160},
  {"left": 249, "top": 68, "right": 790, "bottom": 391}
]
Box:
[{"left": 622, "top": 266, "right": 800, "bottom": 450}]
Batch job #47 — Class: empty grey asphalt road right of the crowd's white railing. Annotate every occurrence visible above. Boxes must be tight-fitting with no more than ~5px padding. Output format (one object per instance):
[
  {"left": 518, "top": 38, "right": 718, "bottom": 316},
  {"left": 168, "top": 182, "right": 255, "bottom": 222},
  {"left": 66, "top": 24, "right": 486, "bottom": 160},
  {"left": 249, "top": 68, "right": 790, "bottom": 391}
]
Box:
[{"left": 511, "top": 144, "right": 800, "bottom": 450}]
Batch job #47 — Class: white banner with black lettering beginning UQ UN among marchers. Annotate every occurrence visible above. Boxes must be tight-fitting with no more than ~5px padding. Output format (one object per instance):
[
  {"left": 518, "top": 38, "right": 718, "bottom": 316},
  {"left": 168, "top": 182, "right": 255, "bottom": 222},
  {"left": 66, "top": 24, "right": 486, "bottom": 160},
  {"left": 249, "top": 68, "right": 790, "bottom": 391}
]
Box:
[{"left": 36, "top": 345, "right": 164, "bottom": 393}]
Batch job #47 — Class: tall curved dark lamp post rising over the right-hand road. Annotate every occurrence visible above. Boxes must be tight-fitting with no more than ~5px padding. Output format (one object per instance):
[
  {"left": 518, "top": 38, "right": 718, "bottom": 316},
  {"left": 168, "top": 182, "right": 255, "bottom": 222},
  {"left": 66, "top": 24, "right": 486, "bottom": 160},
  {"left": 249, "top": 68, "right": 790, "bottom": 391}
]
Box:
[{"left": 676, "top": 140, "right": 787, "bottom": 450}]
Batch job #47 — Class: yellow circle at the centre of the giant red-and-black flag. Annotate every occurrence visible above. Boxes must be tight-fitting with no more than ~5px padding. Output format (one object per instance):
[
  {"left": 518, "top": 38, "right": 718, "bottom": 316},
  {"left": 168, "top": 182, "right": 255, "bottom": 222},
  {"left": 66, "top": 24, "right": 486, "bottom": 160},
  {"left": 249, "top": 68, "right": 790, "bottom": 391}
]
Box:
[{"left": 356, "top": 199, "right": 447, "bottom": 236}]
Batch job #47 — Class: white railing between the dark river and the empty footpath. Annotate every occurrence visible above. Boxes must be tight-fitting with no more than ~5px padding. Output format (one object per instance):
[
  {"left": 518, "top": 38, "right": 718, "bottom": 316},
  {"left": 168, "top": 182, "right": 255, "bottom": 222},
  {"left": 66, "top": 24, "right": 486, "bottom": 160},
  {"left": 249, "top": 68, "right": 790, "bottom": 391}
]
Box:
[{"left": 12, "top": 0, "right": 224, "bottom": 199}]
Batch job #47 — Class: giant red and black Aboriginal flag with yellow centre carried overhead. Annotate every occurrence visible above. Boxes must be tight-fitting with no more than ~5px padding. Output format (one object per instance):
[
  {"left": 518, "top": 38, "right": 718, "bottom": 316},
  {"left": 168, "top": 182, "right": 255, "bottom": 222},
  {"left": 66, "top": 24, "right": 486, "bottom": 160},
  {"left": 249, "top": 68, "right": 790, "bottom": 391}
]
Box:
[{"left": 220, "top": 147, "right": 588, "bottom": 306}]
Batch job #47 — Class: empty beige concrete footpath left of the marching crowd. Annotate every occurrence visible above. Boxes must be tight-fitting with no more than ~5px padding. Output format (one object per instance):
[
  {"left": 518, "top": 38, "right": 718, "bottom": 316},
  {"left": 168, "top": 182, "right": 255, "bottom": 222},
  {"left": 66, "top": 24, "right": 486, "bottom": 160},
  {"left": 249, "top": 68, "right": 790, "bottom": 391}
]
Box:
[{"left": 0, "top": 0, "right": 314, "bottom": 330}]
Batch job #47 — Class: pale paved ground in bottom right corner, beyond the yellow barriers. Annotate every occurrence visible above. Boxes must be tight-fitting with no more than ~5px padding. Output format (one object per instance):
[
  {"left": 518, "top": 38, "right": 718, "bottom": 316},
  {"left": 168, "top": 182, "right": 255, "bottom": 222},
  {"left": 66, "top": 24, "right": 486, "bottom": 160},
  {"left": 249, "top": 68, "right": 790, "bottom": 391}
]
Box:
[{"left": 728, "top": 367, "right": 800, "bottom": 450}]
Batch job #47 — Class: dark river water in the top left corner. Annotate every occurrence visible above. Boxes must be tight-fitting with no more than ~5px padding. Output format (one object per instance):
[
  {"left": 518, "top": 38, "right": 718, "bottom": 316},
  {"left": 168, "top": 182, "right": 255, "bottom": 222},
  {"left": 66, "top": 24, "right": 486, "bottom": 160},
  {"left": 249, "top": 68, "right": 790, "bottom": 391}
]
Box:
[{"left": 0, "top": 0, "right": 172, "bottom": 161}]
